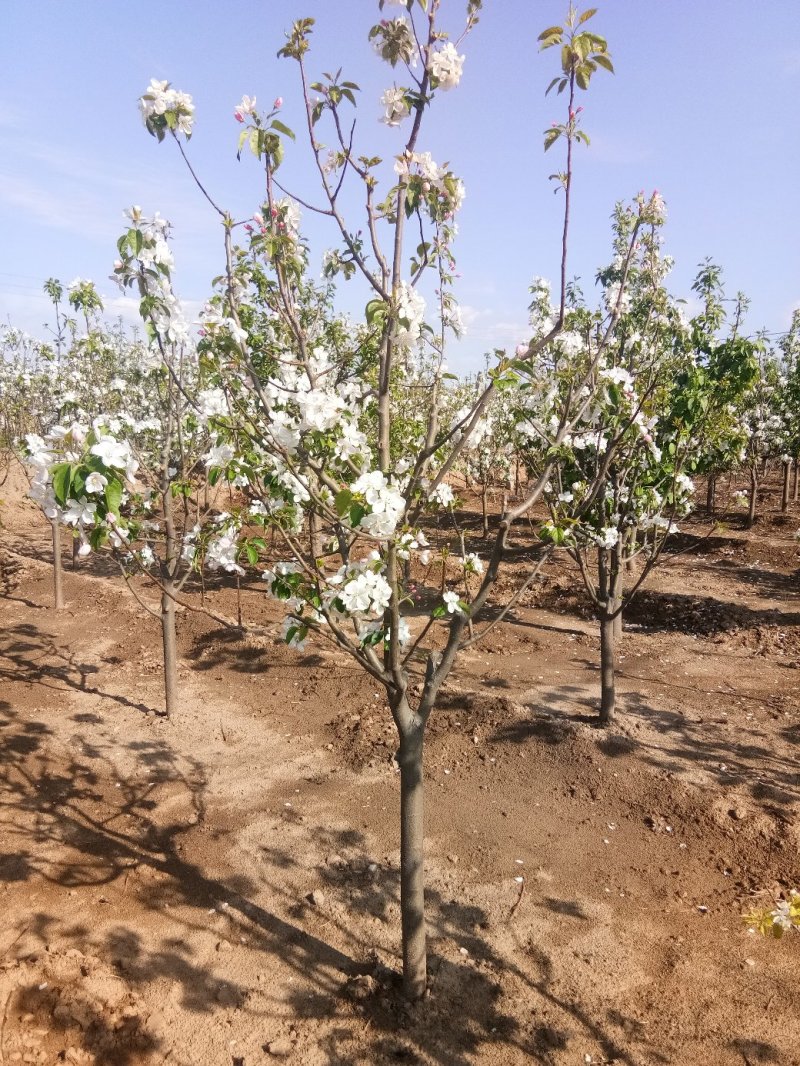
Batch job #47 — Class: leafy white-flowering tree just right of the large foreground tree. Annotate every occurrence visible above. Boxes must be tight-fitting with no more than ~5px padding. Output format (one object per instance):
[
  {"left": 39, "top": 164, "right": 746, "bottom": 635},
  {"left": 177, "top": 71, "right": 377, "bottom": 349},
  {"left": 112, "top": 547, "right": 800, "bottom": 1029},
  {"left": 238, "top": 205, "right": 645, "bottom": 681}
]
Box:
[{"left": 518, "top": 193, "right": 693, "bottom": 725}]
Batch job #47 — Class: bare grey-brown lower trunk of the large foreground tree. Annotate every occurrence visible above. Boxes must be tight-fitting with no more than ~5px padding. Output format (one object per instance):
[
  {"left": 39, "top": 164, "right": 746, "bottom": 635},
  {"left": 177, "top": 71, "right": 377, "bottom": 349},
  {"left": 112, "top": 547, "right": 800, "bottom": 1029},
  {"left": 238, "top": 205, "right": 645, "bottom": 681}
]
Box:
[{"left": 398, "top": 725, "right": 428, "bottom": 1000}]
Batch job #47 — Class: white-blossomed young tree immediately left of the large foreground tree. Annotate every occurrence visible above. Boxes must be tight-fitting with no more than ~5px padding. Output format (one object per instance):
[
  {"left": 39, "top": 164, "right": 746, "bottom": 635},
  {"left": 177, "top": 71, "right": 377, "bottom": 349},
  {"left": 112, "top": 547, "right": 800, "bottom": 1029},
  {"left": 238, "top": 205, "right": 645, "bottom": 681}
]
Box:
[{"left": 18, "top": 239, "right": 228, "bottom": 715}]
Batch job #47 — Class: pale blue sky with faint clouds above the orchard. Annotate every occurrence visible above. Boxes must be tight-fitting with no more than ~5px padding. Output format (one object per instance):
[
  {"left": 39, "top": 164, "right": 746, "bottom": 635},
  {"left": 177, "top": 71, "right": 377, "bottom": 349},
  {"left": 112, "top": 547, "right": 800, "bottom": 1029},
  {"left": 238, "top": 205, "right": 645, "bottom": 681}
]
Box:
[{"left": 0, "top": 0, "right": 800, "bottom": 369}]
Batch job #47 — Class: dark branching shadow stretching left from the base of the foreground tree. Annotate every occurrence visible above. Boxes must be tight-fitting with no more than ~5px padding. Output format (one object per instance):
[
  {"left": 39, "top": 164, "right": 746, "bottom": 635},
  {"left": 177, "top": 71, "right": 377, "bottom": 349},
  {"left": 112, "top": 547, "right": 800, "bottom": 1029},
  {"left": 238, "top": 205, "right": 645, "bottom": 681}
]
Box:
[{"left": 0, "top": 706, "right": 665, "bottom": 1066}]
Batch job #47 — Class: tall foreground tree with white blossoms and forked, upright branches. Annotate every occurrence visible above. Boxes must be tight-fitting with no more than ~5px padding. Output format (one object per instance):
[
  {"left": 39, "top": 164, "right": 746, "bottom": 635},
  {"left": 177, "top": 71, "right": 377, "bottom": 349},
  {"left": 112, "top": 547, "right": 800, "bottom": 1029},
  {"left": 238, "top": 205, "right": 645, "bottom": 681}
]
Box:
[{"left": 131, "top": 0, "right": 610, "bottom": 998}]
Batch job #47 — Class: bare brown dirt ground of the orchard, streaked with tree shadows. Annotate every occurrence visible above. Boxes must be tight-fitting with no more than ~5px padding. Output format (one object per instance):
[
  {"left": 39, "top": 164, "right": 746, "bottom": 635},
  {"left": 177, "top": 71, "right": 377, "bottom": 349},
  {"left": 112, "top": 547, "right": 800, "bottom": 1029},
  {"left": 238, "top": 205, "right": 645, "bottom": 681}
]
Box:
[{"left": 0, "top": 469, "right": 800, "bottom": 1066}]
